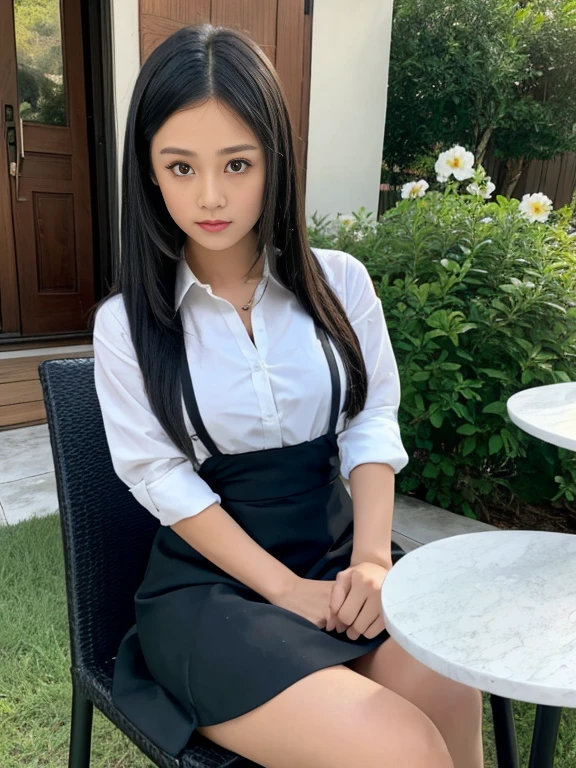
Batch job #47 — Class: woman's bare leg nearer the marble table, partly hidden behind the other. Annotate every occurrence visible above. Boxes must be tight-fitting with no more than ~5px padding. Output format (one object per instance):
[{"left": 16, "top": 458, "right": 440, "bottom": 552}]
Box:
[{"left": 347, "top": 638, "right": 484, "bottom": 768}]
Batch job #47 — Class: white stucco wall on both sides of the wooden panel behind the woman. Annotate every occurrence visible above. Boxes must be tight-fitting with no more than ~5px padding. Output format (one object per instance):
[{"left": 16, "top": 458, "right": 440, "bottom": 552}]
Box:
[{"left": 112, "top": 0, "right": 393, "bottom": 220}]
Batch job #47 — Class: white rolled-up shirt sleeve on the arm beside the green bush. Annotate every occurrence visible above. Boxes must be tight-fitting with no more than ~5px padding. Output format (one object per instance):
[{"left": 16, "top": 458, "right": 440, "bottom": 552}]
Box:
[{"left": 338, "top": 257, "right": 409, "bottom": 479}]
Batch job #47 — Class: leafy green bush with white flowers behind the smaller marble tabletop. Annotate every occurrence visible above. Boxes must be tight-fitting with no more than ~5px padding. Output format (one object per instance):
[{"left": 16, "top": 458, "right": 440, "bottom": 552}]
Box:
[{"left": 310, "top": 148, "right": 576, "bottom": 520}]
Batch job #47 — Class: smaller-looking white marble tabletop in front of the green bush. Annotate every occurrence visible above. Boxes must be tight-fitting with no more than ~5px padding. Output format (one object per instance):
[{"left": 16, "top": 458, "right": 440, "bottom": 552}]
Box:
[{"left": 506, "top": 381, "right": 576, "bottom": 451}]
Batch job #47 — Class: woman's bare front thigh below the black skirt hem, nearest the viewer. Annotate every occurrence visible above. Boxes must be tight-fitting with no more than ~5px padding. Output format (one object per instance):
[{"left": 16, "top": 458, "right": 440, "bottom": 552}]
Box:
[{"left": 198, "top": 665, "right": 452, "bottom": 768}]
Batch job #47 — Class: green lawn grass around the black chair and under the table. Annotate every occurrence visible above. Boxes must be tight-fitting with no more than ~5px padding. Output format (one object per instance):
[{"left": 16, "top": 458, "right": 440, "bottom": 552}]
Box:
[{"left": 0, "top": 515, "right": 576, "bottom": 768}]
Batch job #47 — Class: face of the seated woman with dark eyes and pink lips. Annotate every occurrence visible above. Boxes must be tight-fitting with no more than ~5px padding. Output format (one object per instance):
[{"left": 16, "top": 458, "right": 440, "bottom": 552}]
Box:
[{"left": 150, "top": 99, "right": 265, "bottom": 251}]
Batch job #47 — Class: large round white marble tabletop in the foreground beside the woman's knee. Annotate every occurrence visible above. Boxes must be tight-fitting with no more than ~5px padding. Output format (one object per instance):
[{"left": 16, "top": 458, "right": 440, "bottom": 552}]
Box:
[{"left": 382, "top": 531, "right": 576, "bottom": 707}]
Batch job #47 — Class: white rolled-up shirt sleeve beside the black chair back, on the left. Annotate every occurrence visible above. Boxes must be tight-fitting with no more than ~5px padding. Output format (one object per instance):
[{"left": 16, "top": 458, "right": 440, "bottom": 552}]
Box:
[{"left": 93, "top": 296, "right": 221, "bottom": 525}]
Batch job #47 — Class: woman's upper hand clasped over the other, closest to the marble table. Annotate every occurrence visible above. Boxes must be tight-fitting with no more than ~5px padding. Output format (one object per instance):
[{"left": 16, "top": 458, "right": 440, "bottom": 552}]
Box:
[{"left": 326, "top": 562, "right": 388, "bottom": 640}]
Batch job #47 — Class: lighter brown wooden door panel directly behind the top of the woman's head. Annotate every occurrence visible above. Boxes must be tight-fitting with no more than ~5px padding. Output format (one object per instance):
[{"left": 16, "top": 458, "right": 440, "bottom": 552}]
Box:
[{"left": 140, "top": 0, "right": 312, "bottom": 174}]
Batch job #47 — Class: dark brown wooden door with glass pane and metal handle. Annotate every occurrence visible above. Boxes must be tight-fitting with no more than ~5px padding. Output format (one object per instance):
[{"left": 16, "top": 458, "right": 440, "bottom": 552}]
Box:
[{"left": 0, "top": 0, "right": 94, "bottom": 340}]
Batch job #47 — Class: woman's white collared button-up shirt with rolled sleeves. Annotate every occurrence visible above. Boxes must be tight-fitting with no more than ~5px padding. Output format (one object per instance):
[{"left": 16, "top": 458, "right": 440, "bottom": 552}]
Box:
[{"left": 93, "top": 248, "right": 408, "bottom": 525}]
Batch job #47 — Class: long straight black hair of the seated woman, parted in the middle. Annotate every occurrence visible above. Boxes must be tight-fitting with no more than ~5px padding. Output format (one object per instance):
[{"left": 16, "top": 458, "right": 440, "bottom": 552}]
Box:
[{"left": 93, "top": 24, "right": 368, "bottom": 463}]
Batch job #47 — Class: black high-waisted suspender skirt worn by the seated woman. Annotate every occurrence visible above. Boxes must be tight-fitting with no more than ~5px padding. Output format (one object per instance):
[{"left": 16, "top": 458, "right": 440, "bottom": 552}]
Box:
[{"left": 113, "top": 328, "right": 398, "bottom": 755}]
